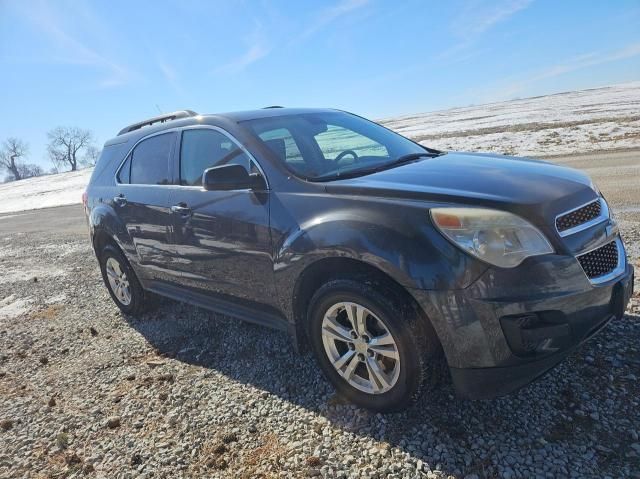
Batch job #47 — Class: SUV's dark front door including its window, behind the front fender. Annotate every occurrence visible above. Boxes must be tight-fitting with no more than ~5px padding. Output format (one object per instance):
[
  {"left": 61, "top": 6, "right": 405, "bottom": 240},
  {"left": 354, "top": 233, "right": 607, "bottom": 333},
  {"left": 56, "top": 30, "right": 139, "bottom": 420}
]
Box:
[{"left": 169, "top": 128, "right": 277, "bottom": 307}]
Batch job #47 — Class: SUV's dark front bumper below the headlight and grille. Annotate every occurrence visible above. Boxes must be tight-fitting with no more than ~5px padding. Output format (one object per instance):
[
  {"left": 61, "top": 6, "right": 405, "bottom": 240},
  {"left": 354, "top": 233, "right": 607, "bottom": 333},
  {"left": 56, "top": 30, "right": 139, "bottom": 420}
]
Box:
[{"left": 412, "top": 249, "right": 634, "bottom": 399}]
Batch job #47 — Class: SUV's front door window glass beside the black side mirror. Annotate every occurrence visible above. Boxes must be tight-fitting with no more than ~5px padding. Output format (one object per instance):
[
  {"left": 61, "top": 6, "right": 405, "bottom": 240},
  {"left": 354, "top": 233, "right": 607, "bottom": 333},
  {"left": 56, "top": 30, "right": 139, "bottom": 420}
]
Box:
[{"left": 180, "top": 129, "right": 251, "bottom": 186}]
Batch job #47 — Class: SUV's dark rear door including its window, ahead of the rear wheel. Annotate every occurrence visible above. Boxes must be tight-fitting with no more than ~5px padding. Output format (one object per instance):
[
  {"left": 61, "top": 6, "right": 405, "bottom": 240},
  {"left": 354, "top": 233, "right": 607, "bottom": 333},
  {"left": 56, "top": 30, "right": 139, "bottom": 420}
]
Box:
[{"left": 113, "top": 131, "right": 177, "bottom": 280}]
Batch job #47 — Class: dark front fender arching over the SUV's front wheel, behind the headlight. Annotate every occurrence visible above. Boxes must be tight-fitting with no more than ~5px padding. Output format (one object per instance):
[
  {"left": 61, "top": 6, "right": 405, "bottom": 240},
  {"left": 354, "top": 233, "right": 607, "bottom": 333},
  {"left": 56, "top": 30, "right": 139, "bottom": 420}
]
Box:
[{"left": 274, "top": 198, "right": 486, "bottom": 321}]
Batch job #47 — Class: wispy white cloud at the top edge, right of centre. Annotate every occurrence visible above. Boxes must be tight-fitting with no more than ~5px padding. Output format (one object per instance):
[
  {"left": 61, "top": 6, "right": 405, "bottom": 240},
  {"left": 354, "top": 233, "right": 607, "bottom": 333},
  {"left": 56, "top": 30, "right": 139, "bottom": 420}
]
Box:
[{"left": 438, "top": 0, "right": 533, "bottom": 59}]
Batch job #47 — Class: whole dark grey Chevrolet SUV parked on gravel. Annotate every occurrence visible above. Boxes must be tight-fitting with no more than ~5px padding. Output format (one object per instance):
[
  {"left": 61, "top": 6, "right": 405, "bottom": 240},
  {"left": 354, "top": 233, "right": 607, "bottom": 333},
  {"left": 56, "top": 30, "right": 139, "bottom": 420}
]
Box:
[{"left": 85, "top": 107, "right": 633, "bottom": 411}]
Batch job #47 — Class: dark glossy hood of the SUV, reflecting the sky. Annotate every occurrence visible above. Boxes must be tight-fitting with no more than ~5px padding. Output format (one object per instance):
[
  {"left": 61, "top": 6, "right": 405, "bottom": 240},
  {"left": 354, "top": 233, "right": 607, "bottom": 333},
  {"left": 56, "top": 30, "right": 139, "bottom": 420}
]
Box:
[{"left": 326, "top": 152, "right": 597, "bottom": 218}]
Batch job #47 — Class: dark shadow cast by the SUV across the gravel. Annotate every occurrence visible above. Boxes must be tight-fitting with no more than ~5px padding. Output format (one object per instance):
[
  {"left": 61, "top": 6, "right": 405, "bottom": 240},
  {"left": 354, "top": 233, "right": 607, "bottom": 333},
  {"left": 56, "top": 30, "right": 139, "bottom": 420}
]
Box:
[{"left": 123, "top": 300, "right": 640, "bottom": 477}]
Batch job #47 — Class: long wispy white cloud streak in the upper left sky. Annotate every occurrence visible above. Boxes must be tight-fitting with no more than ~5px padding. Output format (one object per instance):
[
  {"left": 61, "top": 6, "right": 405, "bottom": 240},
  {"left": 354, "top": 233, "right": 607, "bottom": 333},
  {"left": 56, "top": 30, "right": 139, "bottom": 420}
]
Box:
[{"left": 10, "top": 2, "right": 135, "bottom": 88}]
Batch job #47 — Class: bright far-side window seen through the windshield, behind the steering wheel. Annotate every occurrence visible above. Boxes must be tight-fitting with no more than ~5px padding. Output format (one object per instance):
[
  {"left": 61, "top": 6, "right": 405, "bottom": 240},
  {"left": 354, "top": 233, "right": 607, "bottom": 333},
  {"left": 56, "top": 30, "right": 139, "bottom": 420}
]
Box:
[{"left": 314, "top": 125, "right": 389, "bottom": 161}]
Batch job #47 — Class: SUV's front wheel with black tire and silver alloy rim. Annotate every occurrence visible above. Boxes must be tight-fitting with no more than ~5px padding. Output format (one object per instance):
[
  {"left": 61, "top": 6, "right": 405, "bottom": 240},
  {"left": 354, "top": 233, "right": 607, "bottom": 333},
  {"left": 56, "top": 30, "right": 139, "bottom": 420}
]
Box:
[{"left": 308, "top": 280, "right": 444, "bottom": 412}]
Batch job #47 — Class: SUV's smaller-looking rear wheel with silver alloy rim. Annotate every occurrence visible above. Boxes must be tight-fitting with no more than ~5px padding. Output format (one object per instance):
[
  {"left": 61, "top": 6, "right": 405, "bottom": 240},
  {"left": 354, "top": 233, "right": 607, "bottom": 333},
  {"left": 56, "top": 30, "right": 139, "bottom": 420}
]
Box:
[{"left": 100, "top": 244, "right": 148, "bottom": 315}]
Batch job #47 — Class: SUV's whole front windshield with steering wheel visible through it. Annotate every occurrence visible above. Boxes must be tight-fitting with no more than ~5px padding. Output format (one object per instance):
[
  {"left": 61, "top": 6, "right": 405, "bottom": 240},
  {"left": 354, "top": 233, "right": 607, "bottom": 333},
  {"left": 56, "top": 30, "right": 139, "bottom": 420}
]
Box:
[{"left": 244, "top": 112, "right": 432, "bottom": 181}]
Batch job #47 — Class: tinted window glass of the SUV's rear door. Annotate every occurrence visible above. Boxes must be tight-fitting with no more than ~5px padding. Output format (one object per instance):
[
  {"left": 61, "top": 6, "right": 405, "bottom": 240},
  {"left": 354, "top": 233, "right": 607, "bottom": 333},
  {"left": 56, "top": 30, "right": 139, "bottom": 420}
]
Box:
[{"left": 129, "top": 133, "right": 174, "bottom": 185}]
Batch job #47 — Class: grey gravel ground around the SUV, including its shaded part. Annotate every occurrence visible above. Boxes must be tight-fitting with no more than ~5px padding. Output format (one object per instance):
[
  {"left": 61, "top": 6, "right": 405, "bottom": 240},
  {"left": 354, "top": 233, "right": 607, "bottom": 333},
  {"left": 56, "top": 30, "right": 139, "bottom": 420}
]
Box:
[{"left": 0, "top": 219, "right": 640, "bottom": 479}]
